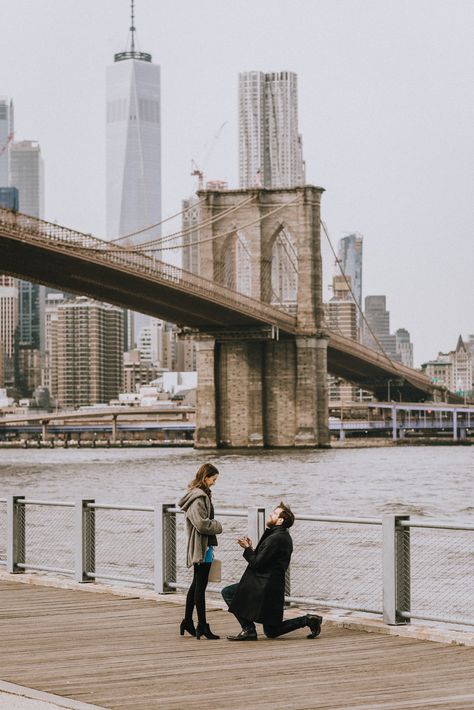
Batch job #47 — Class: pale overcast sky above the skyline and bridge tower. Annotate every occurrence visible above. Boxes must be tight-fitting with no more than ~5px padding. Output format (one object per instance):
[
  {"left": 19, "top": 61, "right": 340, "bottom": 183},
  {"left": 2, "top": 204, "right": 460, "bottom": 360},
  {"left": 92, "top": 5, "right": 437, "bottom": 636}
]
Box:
[{"left": 0, "top": 0, "right": 474, "bottom": 363}]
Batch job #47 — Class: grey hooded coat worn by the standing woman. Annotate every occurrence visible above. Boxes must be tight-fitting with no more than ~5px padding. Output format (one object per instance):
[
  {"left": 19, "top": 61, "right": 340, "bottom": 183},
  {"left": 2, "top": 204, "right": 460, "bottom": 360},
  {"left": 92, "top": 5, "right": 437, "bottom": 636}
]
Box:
[{"left": 178, "top": 488, "right": 222, "bottom": 567}]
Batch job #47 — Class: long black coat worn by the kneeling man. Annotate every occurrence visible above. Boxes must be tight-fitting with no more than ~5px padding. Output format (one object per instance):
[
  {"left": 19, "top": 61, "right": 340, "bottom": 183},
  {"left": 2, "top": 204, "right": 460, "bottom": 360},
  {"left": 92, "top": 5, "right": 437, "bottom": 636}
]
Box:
[{"left": 229, "top": 525, "right": 293, "bottom": 626}]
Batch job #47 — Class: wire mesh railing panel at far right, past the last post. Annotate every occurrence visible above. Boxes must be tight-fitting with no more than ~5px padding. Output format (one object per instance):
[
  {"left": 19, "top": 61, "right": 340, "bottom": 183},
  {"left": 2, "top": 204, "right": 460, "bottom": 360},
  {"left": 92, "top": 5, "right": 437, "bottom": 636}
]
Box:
[{"left": 406, "top": 527, "right": 474, "bottom": 624}]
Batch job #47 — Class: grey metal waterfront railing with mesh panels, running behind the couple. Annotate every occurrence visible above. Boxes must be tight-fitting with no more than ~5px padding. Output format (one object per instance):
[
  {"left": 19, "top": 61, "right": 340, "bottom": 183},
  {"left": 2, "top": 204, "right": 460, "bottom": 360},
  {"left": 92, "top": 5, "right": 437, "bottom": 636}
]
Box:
[{"left": 0, "top": 496, "right": 474, "bottom": 626}]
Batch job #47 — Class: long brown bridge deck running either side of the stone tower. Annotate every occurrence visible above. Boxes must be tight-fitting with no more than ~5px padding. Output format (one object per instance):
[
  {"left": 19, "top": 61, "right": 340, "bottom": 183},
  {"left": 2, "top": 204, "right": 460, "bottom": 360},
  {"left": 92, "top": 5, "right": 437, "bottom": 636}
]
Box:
[{"left": 0, "top": 208, "right": 452, "bottom": 403}]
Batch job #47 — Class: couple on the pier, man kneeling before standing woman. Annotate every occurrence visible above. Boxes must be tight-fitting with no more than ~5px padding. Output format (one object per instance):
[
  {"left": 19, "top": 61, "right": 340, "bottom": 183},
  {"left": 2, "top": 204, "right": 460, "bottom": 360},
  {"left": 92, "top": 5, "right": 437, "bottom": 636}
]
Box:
[{"left": 178, "top": 463, "right": 322, "bottom": 641}]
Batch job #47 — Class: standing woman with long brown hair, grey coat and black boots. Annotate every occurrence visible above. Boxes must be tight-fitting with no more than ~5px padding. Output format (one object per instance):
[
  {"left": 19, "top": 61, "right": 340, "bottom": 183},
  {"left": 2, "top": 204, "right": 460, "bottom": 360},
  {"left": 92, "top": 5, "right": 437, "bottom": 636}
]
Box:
[{"left": 178, "top": 463, "right": 222, "bottom": 639}]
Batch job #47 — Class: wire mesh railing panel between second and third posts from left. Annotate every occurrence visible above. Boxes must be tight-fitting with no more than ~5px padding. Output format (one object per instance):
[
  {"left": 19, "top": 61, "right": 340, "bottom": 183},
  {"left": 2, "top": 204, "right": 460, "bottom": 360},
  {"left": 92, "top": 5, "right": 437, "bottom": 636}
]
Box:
[{"left": 91, "top": 508, "right": 154, "bottom": 584}]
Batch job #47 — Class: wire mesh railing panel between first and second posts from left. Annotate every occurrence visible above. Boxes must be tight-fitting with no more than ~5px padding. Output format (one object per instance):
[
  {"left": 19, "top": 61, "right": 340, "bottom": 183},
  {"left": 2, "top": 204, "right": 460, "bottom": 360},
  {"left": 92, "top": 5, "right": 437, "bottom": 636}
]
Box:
[{"left": 23, "top": 503, "right": 74, "bottom": 574}]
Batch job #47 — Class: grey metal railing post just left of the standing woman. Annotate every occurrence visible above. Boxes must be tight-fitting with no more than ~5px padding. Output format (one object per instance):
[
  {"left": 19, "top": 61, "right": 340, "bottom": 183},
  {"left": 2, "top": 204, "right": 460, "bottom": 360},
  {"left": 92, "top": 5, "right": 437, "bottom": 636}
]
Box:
[{"left": 155, "top": 503, "right": 176, "bottom": 594}]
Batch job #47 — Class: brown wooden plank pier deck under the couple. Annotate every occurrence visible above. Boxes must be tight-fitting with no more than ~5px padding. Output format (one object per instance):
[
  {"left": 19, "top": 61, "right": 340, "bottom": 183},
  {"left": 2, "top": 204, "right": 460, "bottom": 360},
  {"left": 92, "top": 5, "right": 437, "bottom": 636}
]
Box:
[{"left": 0, "top": 580, "right": 474, "bottom": 710}]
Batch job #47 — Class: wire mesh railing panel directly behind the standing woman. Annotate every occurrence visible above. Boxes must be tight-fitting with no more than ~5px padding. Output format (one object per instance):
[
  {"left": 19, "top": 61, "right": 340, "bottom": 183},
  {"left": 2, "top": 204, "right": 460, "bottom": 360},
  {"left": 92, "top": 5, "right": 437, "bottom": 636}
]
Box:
[{"left": 176, "top": 512, "right": 250, "bottom": 594}]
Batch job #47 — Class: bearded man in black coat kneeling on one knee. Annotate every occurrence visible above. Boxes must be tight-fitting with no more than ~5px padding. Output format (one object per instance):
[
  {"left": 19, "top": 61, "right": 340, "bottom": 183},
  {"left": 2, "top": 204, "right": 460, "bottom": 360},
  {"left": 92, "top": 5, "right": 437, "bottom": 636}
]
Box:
[{"left": 222, "top": 503, "right": 322, "bottom": 641}]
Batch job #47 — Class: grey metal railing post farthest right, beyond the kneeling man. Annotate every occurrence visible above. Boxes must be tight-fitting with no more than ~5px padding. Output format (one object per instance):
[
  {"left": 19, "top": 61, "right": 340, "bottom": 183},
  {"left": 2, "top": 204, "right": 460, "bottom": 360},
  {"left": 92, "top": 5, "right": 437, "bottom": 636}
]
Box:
[{"left": 382, "top": 515, "right": 410, "bottom": 625}]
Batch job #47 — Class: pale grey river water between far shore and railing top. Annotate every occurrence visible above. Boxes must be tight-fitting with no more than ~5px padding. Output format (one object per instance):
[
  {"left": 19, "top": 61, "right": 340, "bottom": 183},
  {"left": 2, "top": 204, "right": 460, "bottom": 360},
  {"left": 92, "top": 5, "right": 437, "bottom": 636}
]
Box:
[{"left": 0, "top": 446, "right": 474, "bottom": 522}]
